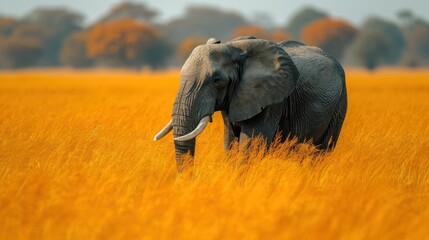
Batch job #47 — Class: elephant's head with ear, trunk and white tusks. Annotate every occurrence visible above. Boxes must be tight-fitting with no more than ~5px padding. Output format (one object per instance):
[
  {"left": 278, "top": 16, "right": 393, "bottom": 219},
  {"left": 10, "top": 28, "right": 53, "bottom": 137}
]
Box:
[{"left": 154, "top": 39, "right": 299, "bottom": 171}]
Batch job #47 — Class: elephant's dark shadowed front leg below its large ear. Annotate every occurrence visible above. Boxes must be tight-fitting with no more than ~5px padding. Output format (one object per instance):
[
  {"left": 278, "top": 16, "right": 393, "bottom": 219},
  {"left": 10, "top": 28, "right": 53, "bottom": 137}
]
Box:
[{"left": 239, "top": 103, "right": 283, "bottom": 152}]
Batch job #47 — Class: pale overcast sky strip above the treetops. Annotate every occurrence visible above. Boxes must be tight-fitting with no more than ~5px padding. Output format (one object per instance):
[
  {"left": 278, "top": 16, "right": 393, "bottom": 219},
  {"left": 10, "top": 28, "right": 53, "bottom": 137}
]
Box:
[{"left": 0, "top": 0, "right": 429, "bottom": 25}]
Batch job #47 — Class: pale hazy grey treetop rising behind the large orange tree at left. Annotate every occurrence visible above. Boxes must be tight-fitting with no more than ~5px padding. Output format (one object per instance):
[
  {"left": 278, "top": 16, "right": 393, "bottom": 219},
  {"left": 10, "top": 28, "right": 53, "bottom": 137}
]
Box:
[{"left": 99, "top": 2, "right": 159, "bottom": 23}]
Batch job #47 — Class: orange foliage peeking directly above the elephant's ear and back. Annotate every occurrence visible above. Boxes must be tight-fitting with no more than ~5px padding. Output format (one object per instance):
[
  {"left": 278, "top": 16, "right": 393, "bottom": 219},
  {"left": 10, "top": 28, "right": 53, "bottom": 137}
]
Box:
[{"left": 232, "top": 25, "right": 291, "bottom": 42}]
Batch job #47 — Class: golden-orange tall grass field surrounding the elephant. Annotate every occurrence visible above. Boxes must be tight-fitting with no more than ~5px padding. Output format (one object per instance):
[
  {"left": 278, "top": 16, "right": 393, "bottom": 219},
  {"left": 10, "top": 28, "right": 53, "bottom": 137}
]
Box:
[{"left": 0, "top": 69, "right": 429, "bottom": 240}]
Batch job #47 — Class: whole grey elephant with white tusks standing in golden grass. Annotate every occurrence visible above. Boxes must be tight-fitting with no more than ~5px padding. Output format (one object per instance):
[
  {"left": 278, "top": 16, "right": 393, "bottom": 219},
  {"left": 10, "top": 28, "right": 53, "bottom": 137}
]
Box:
[{"left": 154, "top": 37, "right": 347, "bottom": 171}]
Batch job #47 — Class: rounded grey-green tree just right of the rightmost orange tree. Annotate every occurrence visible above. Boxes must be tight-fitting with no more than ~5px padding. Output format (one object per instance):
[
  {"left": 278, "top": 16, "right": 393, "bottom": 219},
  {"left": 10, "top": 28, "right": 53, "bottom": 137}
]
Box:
[{"left": 352, "top": 18, "right": 405, "bottom": 69}]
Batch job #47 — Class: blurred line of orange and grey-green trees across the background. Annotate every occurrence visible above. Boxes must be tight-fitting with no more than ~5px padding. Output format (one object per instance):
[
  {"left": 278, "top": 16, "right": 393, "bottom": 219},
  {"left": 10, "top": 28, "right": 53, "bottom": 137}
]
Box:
[{"left": 0, "top": 2, "right": 429, "bottom": 69}]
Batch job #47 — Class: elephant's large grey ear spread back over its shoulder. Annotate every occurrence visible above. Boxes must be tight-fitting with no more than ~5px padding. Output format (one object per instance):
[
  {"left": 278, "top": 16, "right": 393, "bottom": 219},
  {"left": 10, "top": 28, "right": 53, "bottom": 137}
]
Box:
[{"left": 228, "top": 39, "right": 299, "bottom": 122}]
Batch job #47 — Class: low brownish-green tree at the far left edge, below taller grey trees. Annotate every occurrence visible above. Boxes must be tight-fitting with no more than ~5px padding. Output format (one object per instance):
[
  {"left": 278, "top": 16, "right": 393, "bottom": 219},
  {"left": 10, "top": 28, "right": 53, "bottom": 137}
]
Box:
[{"left": 0, "top": 38, "right": 42, "bottom": 68}]
